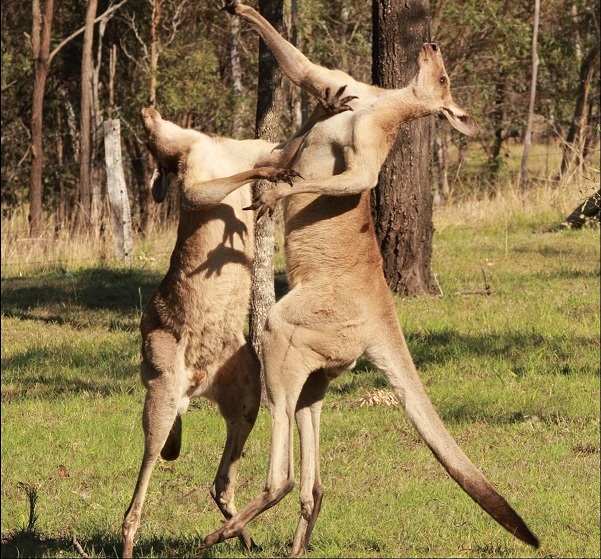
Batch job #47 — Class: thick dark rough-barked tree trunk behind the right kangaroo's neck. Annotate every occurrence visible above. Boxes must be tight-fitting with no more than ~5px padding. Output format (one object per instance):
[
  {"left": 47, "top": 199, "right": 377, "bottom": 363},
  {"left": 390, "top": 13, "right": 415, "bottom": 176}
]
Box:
[{"left": 372, "top": 0, "right": 434, "bottom": 295}]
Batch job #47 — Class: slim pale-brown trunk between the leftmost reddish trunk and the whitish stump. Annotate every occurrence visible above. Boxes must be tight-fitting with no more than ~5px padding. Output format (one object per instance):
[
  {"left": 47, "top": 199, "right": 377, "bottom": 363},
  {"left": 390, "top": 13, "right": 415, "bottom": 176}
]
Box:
[{"left": 78, "top": 0, "right": 98, "bottom": 234}]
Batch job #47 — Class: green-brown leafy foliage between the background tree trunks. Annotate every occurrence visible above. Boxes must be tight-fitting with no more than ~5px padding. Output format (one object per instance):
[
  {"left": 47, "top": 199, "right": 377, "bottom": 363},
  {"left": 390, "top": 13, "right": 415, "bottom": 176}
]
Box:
[{"left": 1, "top": 0, "right": 599, "bottom": 227}]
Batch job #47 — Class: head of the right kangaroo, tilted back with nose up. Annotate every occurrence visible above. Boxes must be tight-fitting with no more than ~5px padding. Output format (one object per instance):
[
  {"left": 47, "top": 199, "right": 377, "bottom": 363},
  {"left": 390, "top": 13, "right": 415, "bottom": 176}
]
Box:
[{"left": 411, "top": 43, "right": 478, "bottom": 136}]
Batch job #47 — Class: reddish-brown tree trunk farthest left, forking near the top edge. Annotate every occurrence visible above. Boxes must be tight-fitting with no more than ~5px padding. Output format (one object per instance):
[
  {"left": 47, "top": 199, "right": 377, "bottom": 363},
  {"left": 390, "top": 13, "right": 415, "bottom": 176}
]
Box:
[{"left": 29, "top": 0, "right": 54, "bottom": 237}]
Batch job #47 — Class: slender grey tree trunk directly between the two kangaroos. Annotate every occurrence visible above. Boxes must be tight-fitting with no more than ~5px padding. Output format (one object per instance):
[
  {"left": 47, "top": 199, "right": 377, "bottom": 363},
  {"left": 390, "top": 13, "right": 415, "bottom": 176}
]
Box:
[{"left": 250, "top": 0, "right": 284, "bottom": 400}]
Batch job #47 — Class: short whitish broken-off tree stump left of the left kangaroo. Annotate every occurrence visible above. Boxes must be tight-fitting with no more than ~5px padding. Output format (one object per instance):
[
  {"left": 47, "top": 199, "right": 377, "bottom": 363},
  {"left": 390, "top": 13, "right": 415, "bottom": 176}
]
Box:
[{"left": 104, "top": 118, "right": 133, "bottom": 265}]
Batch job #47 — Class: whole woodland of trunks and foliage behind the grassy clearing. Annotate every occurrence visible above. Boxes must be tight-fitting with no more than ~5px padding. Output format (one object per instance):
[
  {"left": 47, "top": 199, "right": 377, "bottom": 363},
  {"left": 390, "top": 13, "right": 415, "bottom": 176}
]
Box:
[{"left": 1, "top": 0, "right": 599, "bottom": 245}]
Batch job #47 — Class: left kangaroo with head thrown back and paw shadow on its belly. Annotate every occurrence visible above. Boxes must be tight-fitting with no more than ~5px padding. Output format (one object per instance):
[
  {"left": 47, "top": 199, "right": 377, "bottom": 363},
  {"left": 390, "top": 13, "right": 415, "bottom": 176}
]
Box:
[{"left": 122, "top": 88, "right": 356, "bottom": 557}]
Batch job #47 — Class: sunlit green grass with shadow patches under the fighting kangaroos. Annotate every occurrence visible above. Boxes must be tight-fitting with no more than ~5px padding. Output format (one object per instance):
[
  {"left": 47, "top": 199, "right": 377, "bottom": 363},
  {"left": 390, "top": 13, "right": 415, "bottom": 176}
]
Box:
[{"left": 1, "top": 182, "right": 600, "bottom": 558}]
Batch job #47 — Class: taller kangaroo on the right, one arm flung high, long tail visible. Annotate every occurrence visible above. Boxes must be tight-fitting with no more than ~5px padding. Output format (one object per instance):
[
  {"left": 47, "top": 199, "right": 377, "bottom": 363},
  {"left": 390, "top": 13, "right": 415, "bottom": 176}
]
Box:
[{"left": 205, "top": 3, "right": 538, "bottom": 556}]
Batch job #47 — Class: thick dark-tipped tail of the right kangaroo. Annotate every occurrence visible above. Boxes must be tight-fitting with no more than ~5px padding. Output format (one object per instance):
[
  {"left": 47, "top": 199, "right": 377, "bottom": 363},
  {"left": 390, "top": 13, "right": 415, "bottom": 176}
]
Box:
[{"left": 373, "top": 339, "right": 539, "bottom": 548}]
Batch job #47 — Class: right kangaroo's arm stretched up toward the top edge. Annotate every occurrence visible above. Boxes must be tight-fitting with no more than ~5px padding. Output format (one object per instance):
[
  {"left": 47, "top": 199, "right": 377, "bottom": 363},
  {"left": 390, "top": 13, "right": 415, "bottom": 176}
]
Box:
[{"left": 223, "top": 0, "right": 354, "bottom": 97}]
